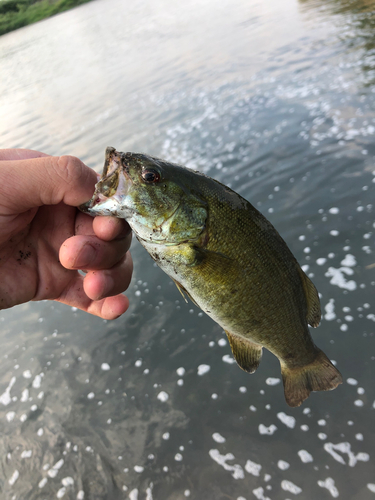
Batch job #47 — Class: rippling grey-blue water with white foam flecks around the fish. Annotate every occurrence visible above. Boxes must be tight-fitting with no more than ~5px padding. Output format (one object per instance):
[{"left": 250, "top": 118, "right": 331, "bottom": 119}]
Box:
[{"left": 0, "top": 0, "right": 375, "bottom": 500}]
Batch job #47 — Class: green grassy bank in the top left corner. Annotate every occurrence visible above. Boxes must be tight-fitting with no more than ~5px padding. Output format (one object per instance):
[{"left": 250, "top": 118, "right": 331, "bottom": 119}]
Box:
[{"left": 0, "top": 0, "right": 93, "bottom": 35}]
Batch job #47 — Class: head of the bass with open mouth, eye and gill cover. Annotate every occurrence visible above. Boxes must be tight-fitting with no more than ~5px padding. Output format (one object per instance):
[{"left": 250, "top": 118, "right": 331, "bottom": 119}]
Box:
[{"left": 80, "top": 148, "right": 207, "bottom": 245}]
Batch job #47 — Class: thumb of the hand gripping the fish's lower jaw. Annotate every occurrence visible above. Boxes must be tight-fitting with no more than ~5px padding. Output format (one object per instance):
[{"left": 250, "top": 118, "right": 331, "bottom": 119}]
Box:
[{"left": 0, "top": 156, "right": 97, "bottom": 213}]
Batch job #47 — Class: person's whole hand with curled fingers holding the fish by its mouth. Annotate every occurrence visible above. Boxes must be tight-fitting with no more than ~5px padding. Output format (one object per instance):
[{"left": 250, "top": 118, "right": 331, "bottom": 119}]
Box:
[{"left": 0, "top": 149, "right": 133, "bottom": 319}]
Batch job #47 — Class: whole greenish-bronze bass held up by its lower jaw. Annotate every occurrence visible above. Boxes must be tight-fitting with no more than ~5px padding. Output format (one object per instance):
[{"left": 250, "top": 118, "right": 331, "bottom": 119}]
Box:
[{"left": 80, "top": 147, "right": 342, "bottom": 407}]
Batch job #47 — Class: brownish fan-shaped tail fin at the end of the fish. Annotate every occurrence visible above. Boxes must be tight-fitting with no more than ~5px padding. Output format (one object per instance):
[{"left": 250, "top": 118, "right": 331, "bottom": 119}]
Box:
[{"left": 281, "top": 348, "right": 342, "bottom": 407}]
